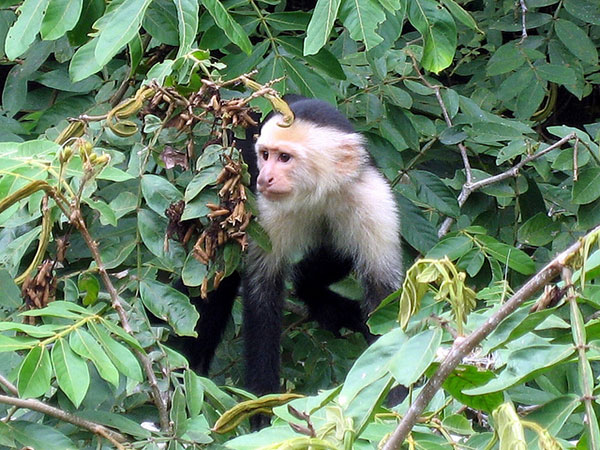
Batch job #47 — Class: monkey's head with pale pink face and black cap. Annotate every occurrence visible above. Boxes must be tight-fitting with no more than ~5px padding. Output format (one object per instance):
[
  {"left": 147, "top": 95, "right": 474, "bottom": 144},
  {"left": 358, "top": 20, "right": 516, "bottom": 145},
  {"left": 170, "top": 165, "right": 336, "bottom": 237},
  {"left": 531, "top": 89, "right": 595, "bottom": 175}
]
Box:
[{"left": 256, "top": 99, "right": 368, "bottom": 201}]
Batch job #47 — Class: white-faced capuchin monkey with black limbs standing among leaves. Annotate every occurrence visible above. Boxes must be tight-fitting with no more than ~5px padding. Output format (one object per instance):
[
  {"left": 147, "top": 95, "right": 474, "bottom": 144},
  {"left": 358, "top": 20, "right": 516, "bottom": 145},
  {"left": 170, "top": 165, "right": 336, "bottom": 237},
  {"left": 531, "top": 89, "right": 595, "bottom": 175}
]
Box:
[{"left": 183, "top": 96, "right": 402, "bottom": 427}]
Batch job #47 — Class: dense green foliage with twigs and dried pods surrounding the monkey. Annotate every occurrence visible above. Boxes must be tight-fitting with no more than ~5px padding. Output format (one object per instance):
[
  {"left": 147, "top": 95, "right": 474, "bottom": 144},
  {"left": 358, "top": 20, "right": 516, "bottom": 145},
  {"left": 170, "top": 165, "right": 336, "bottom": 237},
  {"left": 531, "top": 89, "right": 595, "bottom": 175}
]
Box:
[{"left": 0, "top": 0, "right": 600, "bottom": 450}]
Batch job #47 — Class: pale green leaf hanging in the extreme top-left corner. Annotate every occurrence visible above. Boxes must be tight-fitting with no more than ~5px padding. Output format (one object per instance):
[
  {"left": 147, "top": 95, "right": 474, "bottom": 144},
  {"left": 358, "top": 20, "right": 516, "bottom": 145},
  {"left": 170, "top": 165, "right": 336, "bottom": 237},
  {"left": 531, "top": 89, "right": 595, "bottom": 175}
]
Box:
[{"left": 4, "top": 0, "right": 50, "bottom": 60}]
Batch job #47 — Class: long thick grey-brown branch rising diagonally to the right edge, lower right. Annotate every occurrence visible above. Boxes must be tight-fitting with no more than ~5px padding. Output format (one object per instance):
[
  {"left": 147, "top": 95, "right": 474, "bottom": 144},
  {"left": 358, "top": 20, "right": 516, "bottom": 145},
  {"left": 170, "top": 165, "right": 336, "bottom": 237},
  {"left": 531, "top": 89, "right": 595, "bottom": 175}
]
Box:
[{"left": 383, "top": 226, "right": 600, "bottom": 450}]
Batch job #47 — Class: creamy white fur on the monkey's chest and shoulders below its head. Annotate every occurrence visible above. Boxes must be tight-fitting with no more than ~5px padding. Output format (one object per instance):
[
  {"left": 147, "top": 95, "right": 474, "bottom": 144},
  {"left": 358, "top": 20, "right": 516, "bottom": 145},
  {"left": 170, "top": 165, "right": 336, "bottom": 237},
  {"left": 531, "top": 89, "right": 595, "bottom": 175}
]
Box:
[{"left": 258, "top": 166, "right": 401, "bottom": 282}]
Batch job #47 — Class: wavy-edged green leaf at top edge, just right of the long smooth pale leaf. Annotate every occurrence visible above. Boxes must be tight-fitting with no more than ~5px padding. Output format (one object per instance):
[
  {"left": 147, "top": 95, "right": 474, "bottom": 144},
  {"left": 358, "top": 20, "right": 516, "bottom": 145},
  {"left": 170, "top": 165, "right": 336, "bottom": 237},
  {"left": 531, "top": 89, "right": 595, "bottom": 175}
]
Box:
[{"left": 338, "top": 0, "right": 385, "bottom": 51}]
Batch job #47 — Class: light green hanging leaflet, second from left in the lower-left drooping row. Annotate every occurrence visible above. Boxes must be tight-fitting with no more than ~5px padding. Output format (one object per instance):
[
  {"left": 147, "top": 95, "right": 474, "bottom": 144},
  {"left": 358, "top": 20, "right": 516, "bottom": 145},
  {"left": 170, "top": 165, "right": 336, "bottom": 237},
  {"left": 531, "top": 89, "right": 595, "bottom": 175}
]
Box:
[{"left": 52, "top": 338, "right": 90, "bottom": 408}]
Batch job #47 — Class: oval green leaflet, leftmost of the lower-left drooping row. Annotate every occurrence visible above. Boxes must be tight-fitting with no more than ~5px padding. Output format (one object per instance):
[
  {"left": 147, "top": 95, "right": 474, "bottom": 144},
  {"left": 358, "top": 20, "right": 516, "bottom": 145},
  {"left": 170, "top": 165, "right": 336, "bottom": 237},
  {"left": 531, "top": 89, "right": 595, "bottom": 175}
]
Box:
[{"left": 17, "top": 345, "right": 52, "bottom": 398}]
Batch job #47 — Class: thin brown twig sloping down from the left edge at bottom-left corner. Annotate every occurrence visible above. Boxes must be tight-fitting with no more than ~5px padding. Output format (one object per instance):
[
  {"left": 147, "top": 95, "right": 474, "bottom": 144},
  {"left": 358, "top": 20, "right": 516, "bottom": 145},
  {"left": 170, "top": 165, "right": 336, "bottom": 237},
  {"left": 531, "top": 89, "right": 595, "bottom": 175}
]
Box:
[{"left": 0, "top": 395, "right": 127, "bottom": 450}]
